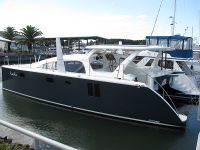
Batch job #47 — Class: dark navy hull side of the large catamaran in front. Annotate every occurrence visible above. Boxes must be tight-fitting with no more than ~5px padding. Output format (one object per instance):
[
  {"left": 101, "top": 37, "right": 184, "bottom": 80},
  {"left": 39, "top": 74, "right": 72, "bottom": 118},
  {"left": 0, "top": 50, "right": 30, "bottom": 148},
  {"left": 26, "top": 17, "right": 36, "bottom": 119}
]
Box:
[{"left": 2, "top": 67, "right": 185, "bottom": 127}]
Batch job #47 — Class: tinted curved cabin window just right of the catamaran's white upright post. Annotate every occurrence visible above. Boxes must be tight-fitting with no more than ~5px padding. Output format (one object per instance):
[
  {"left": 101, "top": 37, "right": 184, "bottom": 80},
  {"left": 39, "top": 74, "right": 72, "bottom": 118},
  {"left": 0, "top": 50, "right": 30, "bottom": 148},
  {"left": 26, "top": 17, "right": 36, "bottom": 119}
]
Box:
[{"left": 65, "top": 61, "right": 85, "bottom": 73}]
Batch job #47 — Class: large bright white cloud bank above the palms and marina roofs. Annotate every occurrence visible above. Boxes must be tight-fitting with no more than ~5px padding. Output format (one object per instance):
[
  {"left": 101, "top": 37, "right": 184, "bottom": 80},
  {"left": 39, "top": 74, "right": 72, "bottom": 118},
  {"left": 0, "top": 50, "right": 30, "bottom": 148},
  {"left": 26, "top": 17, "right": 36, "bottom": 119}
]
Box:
[{"left": 0, "top": 0, "right": 149, "bottom": 39}]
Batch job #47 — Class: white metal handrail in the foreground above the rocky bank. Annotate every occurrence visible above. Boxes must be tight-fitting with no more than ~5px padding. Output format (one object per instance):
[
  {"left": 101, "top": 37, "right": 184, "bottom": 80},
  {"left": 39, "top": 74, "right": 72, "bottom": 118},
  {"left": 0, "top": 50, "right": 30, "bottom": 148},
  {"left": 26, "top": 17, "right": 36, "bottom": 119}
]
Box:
[{"left": 0, "top": 120, "right": 77, "bottom": 150}]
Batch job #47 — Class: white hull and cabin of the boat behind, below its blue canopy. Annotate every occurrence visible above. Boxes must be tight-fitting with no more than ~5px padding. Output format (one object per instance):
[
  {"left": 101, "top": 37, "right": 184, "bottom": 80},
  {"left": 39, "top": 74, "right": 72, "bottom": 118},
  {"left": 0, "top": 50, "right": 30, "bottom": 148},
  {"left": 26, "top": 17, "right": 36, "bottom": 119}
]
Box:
[{"left": 134, "top": 51, "right": 200, "bottom": 104}]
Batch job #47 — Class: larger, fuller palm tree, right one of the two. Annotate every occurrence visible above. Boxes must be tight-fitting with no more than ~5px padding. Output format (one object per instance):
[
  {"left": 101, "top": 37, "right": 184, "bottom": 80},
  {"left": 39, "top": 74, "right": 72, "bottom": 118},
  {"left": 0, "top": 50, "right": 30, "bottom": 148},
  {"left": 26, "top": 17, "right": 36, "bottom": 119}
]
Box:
[{"left": 18, "top": 25, "right": 43, "bottom": 52}]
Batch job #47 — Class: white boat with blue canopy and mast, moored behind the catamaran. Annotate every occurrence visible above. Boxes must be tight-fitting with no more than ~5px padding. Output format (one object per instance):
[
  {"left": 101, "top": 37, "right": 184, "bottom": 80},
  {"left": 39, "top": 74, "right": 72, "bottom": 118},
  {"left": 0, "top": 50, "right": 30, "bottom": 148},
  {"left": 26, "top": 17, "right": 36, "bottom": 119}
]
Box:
[{"left": 142, "top": 0, "right": 200, "bottom": 104}]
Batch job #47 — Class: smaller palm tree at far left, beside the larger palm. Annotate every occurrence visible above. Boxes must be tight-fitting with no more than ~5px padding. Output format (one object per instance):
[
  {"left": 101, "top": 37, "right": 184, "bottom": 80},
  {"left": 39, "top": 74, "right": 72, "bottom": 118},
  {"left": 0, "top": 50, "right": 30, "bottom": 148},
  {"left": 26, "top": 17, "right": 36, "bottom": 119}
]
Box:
[{"left": 0, "top": 26, "right": 18, "bottom": 52}]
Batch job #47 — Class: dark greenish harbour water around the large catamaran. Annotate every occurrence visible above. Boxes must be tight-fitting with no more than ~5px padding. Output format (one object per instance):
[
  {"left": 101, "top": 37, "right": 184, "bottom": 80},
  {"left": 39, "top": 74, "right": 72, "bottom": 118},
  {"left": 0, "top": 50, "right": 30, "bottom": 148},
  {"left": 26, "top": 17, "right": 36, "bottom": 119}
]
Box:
[{"left": 0, "top": 69, "right": 200, "bottom": 150}]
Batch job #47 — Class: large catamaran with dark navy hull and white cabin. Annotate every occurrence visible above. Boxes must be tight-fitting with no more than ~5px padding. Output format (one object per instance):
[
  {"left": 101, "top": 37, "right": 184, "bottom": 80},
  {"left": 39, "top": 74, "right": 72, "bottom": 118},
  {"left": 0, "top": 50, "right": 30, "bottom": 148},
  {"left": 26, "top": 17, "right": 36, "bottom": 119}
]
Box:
[{"left": 2, "top": 38, "right": 187, "bottom": 127}]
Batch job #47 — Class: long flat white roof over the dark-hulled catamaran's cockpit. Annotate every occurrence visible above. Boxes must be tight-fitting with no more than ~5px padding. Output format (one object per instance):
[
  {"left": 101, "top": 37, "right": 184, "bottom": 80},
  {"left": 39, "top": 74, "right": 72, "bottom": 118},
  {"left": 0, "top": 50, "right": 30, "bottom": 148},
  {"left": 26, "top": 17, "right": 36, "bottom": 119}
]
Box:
[{"left": 86, "top": 45, "right": 175, "bottom": 51}]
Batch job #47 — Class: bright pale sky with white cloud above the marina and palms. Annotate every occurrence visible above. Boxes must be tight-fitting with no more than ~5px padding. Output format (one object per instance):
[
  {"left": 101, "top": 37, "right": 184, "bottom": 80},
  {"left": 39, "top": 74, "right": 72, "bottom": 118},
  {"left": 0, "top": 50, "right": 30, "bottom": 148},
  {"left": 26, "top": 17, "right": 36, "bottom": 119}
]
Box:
[{"left": 0, "top": 0, "right": 200, "bottom": 41}]
